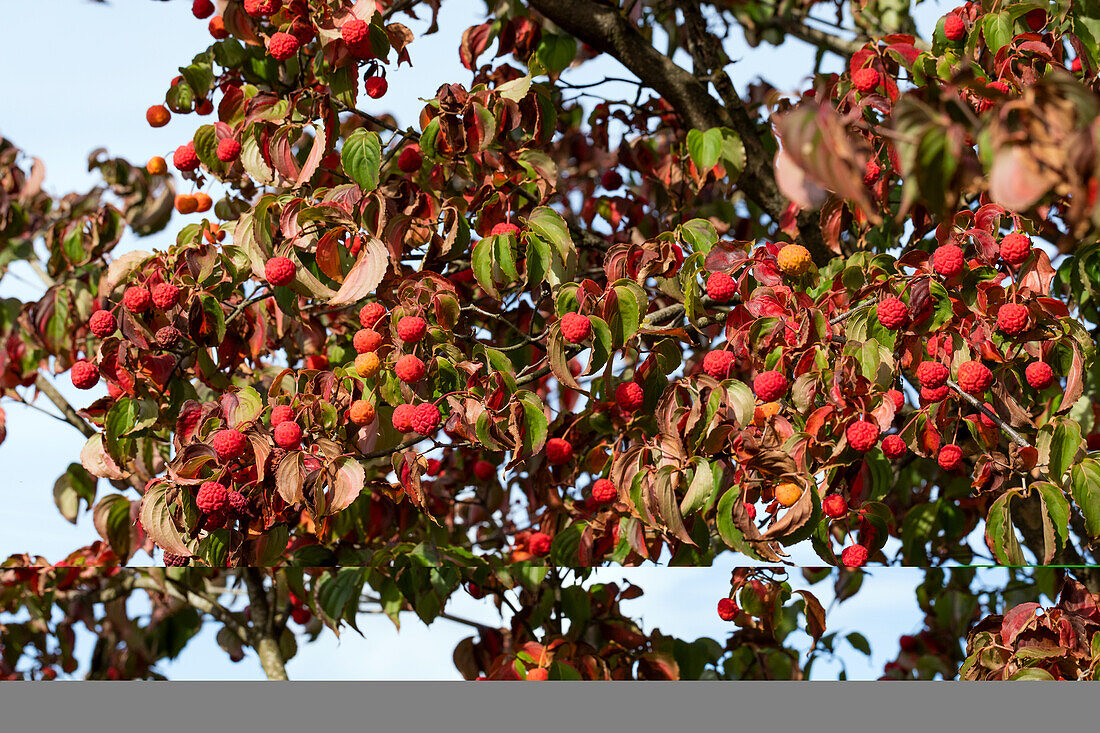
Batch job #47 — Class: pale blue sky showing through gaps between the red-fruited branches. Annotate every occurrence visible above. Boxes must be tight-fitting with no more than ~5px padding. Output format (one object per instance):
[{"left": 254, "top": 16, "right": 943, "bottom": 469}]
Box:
[{"left": 0, "top": 0, "right": 953, "bottom": 679}]
